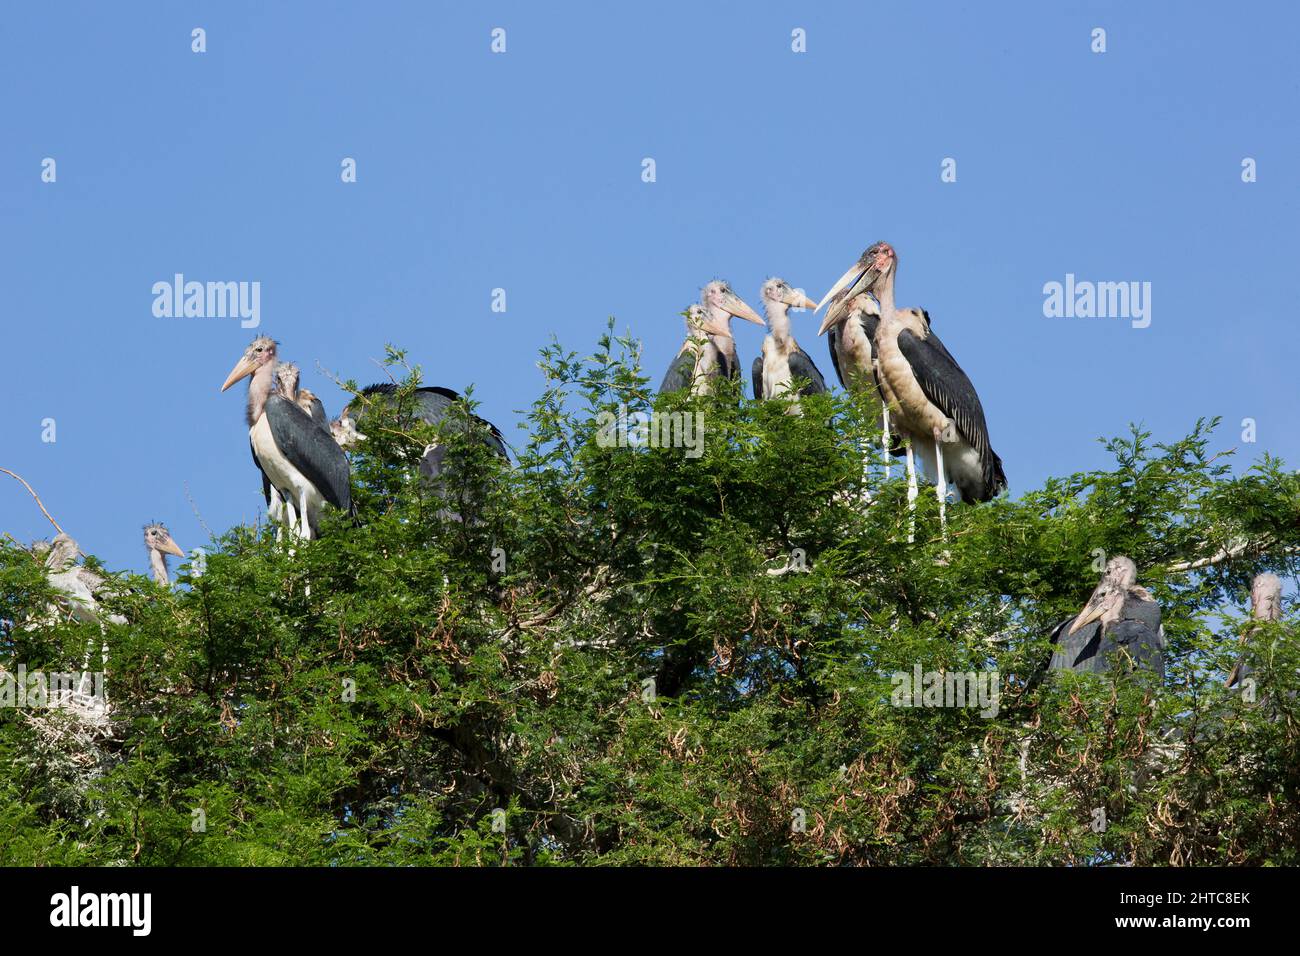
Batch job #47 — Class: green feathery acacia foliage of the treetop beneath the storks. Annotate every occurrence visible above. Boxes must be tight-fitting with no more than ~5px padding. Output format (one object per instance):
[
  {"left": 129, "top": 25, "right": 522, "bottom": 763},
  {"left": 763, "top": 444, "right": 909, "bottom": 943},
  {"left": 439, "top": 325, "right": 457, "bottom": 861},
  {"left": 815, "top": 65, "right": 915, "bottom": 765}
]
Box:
[{"left": 0, "top": 325, "right": 1300, "bottom": 866}]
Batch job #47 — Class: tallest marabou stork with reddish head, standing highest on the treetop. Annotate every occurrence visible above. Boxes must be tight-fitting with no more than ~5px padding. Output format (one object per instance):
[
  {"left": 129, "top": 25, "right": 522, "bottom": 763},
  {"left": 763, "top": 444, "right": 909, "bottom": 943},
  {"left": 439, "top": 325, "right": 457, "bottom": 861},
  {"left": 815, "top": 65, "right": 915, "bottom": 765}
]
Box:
[{"left": 822, "top": 242, "right": 1006, "bottom": 522}]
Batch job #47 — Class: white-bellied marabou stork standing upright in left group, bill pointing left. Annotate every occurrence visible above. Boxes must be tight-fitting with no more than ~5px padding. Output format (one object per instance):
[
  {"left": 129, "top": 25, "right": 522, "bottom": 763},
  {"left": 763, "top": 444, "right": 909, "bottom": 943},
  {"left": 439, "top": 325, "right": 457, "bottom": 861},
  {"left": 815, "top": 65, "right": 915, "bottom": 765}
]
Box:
[{"left": 221, "top": 336, "right": 352, "bottom": 540}]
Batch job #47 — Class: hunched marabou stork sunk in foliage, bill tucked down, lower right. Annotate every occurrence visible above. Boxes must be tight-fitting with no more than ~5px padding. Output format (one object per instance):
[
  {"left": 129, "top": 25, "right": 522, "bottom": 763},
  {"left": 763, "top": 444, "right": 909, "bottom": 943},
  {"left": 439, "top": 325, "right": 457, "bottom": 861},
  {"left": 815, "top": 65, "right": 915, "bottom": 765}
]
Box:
[{"left": 1048, "top": 555, "right": 1165, "bottom": 678}]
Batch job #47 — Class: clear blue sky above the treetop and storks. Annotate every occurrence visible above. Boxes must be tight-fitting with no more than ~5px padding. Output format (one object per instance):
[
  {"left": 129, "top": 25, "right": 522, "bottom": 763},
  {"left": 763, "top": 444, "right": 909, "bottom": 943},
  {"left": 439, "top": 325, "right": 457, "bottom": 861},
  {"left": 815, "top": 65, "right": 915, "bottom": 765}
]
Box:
[{"left": 0, "top": 0, "right": 1300, "bottom": 570}]
